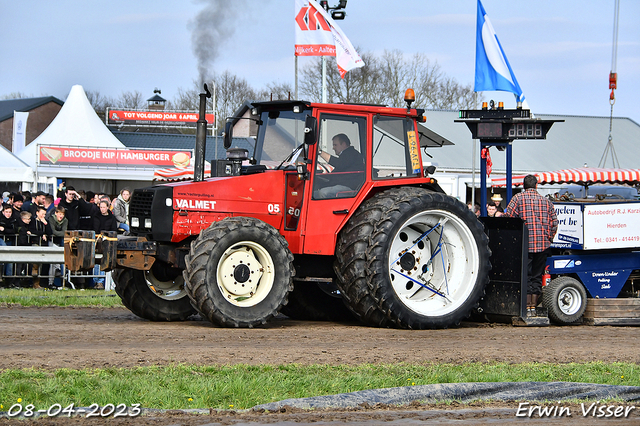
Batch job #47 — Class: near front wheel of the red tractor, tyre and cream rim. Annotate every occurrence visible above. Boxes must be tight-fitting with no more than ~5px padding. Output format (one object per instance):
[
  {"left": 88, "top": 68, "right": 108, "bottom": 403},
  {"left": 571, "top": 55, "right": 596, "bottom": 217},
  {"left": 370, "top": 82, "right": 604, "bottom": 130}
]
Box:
[{"left": 183, "top": 217, "right": 295, "bottom": 327}]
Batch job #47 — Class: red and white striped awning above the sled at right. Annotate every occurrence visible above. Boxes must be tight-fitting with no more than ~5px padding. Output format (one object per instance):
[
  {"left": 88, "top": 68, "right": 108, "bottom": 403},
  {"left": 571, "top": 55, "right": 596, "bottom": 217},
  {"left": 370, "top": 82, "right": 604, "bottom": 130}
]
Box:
[{"left": 491, "top": 167, "right": 640, "bottom": 187}]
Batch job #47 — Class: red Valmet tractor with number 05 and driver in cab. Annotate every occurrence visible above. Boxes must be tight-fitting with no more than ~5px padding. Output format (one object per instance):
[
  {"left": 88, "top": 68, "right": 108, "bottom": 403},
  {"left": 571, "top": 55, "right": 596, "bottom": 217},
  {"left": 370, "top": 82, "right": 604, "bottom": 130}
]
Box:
[{"left": 67, "top": 90, "right": 491, "bottom": 329}]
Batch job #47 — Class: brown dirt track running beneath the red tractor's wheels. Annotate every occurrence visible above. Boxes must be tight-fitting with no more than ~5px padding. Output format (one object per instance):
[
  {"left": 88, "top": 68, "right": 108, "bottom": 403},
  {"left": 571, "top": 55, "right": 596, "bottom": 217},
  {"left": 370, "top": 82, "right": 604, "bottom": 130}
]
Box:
[{"left": 0, "top": 306, "right": 640, "bottom": 425}]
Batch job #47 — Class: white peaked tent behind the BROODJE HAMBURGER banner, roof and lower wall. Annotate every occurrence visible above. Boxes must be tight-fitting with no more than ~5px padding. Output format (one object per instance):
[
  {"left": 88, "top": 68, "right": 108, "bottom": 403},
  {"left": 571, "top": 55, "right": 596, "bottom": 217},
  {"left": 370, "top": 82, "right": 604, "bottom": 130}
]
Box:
[{"left": 18, "top": 85, "right": 153, "bottom": 182}]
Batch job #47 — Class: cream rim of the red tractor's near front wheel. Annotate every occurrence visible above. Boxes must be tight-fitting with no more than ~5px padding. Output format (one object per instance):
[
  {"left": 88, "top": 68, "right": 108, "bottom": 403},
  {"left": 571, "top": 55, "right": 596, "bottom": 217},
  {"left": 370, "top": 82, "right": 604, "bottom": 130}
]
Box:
[{"left": 216, "top": 241, "right": 275, "bottom": 307}]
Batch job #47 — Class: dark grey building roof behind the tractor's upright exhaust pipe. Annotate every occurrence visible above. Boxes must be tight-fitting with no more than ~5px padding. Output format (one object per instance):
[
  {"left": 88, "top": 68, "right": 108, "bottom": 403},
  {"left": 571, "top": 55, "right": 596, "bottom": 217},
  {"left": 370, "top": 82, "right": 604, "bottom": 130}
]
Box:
[{"left": 113, "top": 131, "right": 265, "bottom": 161}]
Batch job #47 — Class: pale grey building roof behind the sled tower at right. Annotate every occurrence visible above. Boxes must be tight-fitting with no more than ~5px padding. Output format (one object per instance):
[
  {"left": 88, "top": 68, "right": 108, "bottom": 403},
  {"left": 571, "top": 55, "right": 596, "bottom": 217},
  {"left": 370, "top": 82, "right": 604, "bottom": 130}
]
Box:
[{"left": 423, "top": 110, "right": 640, "bottom": 173}]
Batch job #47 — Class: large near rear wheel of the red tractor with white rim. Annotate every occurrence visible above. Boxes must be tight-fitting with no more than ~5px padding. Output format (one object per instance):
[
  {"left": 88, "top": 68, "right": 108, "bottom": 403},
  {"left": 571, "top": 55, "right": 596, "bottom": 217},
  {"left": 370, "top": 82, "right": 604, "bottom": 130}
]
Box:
[{"left": 334, "top": 187, "right": 491, "bottom": 329}]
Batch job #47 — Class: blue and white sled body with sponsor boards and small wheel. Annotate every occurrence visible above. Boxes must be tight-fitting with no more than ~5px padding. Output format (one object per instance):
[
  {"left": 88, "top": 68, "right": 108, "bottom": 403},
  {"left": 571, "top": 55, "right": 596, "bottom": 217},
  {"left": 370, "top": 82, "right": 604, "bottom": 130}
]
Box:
[{"left": 542, "top": 196, "right": 640, "bottom": 324}]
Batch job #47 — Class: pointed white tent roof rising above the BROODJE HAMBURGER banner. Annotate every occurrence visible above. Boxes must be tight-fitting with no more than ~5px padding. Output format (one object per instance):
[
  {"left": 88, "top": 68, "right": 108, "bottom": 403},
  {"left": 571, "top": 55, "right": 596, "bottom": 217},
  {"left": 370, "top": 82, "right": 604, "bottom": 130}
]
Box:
[{"left": 18, "top": 85, "right": 126, "bottom": 168}]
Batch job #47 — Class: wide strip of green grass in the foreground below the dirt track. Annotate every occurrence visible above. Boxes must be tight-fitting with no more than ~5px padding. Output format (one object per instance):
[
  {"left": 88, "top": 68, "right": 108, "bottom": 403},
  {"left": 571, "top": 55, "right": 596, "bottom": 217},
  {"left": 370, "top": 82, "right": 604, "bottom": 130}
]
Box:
[{"left": 0, "top": 362, "right": 640, "bottom": 411}]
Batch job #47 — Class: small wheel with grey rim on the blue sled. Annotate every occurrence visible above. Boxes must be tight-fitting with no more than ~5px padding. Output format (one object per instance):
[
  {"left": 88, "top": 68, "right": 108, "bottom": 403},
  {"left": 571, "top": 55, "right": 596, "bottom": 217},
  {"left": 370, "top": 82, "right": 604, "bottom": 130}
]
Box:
[{"left": 542, "top": 276, "right": 587, "bottom": 324}]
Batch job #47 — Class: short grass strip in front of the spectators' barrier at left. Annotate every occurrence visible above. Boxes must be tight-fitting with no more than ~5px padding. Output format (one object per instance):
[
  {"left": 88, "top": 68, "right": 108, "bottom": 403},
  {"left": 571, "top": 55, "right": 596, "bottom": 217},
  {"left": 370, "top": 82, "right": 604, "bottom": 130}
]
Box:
[{"left": 0, "top": 288, "right": 122, "bottom": 307}]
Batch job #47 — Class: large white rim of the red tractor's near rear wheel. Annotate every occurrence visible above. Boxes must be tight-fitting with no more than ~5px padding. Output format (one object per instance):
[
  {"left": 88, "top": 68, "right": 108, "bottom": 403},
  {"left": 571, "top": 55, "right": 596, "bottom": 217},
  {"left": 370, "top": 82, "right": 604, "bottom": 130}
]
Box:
[{"left": 389, "top": 210, "right": 480, "bottom": 317}]
